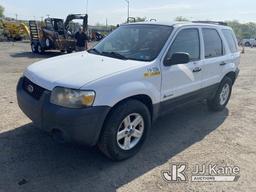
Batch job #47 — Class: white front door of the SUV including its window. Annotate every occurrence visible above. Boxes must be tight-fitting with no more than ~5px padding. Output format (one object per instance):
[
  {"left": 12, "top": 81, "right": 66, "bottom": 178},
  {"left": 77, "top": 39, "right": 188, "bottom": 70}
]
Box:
[{"left": 161, "top": 27, "right": 202, "bottom": 102}]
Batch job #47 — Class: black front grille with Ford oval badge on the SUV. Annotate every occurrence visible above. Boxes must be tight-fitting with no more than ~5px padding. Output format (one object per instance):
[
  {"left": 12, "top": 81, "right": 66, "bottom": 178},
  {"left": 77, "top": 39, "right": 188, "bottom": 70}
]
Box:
[{"left": 22, "top": 77, "right": 45, "bottom": 100}]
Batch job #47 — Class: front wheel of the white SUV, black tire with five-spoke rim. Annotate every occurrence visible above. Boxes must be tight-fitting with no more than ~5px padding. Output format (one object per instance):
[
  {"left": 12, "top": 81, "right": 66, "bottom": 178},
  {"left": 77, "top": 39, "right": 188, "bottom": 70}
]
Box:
[{"left": 98, "top": 100, "right": 151, "bottom": 161}]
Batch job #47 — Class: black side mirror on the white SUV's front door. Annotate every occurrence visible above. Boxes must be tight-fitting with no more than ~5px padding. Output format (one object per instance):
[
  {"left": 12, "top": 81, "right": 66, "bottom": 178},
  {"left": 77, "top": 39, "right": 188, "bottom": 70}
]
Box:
[{"left": 164, "top": 52, "right": 190, "bottom": 66}]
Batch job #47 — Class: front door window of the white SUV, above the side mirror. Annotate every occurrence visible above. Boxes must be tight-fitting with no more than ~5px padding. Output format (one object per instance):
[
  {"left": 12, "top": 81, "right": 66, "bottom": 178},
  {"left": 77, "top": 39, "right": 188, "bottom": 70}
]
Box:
[{"left": 167, "top": 28, "right": 200, "bottom": 61}]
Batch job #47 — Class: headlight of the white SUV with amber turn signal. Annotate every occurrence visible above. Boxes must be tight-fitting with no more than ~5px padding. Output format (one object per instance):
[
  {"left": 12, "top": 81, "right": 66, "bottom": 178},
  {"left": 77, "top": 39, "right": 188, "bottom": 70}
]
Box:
[{"left": 50, "top": 87, "right": 95, "bottom": 108}]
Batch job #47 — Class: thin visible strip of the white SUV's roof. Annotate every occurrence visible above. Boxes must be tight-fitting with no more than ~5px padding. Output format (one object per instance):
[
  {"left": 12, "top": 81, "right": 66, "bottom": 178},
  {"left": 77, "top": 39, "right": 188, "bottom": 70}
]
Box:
[{"left": 124, "top": 21, "right": 231, "bottom": 29}]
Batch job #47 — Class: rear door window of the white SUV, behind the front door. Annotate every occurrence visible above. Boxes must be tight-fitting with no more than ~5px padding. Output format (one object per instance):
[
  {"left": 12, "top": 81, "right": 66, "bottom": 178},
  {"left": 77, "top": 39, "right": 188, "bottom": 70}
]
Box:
[{"left": 203, "top": 29, "right": 224, "bottom": 58}]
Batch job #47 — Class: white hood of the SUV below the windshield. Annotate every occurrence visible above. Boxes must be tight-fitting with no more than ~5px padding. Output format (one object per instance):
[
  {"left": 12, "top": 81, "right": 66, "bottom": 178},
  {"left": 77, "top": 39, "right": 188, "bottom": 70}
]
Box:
[{"left": 24, "top": 52, "right": 144, "bottom": 90}]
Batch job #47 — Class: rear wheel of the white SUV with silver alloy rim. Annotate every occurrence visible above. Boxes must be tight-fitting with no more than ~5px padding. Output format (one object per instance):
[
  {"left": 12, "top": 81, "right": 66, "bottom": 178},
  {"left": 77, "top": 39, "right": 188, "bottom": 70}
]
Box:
[{"left": 207, "top": 77, "right": 233, "bottom": 111}]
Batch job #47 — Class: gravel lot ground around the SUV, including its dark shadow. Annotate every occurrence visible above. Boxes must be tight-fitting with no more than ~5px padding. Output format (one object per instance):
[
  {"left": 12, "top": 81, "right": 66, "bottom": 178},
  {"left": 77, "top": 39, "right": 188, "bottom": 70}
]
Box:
[{"left": 0, "top": 43, "right": 256, "bottom": 192}]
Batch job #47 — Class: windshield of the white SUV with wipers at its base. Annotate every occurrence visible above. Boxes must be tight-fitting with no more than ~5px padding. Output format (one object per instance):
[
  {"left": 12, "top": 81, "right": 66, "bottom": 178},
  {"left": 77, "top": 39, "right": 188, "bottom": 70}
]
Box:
[{"left": 89, "top": 24, "right": 173, "bottom": 61}]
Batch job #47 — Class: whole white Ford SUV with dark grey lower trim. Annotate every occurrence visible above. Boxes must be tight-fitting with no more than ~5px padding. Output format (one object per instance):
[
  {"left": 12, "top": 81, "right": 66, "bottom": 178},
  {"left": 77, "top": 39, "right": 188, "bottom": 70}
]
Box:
[{"left": 17, "top": 23, "right": 240, "bottom": 160}]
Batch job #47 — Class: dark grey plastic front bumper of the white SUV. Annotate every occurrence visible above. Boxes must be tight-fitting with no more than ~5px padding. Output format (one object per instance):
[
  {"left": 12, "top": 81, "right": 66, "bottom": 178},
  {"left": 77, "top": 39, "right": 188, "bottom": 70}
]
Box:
[{"left": 17, "top": 77, "right": 110, "bottom": 146}]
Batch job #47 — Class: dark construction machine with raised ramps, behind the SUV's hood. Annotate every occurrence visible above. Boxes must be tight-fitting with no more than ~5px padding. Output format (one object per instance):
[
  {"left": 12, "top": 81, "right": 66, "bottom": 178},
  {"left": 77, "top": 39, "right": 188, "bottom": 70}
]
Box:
[{"left": 29, "top": 14, "right": 88, "bottom": 54}]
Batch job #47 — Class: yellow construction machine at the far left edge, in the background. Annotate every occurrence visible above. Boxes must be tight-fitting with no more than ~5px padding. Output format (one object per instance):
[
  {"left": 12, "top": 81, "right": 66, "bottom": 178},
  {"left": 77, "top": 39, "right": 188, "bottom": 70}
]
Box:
[{"left": 0, "top": 19, "right": 30, "bottom": 41}]
